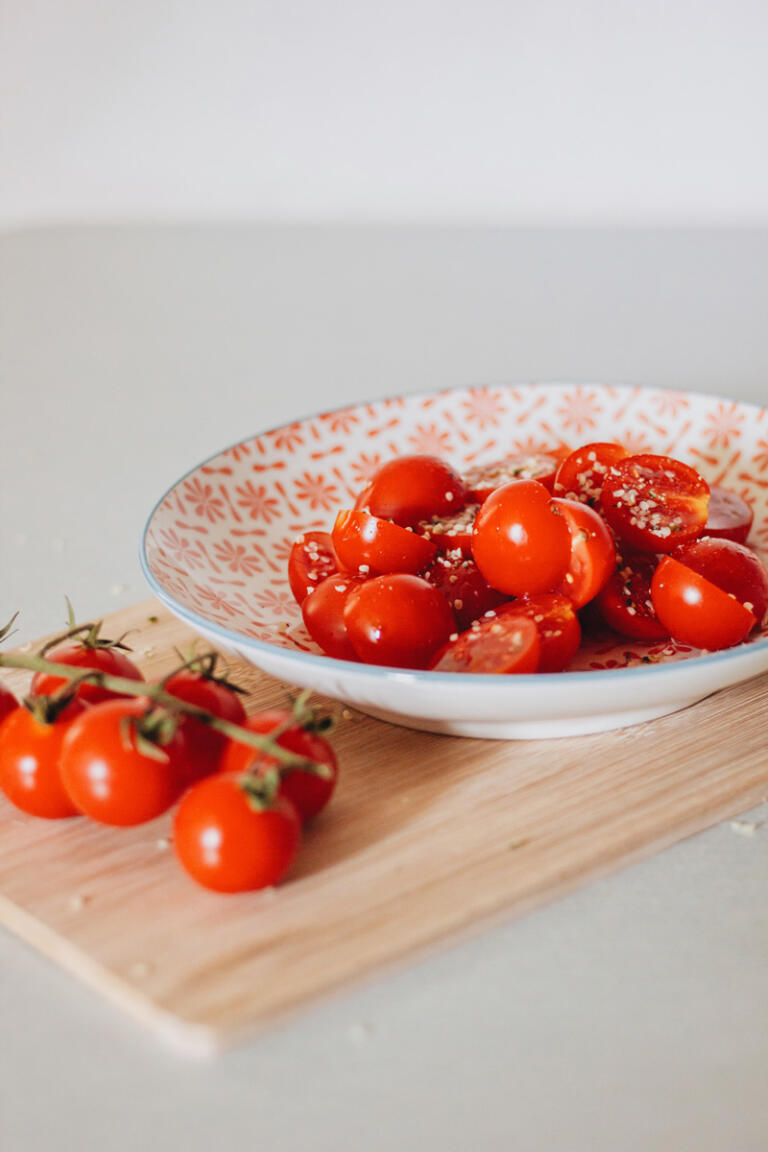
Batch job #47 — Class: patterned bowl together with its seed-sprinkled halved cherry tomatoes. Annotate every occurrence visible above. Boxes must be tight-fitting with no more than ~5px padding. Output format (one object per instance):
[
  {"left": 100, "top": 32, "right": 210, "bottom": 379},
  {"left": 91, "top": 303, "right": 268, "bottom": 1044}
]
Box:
[{"left": 143, "top": 385, "right": 768, "bottom": 737}]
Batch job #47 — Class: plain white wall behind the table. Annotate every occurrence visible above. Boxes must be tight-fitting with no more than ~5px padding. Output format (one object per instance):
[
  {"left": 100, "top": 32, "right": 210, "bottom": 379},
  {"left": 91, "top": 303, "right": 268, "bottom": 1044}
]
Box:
[{"left": 0, "top": 0, "right": 768, "bottom": 227}]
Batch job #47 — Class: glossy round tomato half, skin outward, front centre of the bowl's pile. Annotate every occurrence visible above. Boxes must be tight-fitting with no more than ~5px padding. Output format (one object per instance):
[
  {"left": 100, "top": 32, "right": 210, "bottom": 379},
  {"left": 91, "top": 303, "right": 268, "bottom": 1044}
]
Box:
[{"left": 472, "top": 480, "right": 571, "bottom": 596}]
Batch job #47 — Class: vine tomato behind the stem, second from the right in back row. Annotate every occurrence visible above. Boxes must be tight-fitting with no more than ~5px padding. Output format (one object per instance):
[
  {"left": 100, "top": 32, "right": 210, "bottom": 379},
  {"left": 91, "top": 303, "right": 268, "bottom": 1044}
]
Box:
[{"left": 165, "top": 668, "right": 245, "bottom": 783}]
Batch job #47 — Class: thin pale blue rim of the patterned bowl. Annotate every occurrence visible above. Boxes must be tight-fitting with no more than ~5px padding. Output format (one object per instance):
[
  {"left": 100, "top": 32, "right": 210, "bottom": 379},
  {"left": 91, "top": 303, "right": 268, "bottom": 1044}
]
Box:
[{"left": 138, "top": 380, "right": 768, "bottom": 692}]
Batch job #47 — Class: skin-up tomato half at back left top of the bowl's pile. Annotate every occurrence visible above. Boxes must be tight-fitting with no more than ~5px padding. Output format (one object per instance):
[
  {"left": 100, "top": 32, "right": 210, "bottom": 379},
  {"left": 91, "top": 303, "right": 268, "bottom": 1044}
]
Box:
[{"left": 355, "top": 456, "right": 465, "bottom": 528}]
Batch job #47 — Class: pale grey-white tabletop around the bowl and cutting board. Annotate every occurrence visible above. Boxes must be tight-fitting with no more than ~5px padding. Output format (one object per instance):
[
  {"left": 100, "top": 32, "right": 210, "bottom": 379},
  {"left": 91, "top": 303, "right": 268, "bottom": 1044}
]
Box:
[{"left": 0, "top": 227, "right": 768, "bottom": 1152}]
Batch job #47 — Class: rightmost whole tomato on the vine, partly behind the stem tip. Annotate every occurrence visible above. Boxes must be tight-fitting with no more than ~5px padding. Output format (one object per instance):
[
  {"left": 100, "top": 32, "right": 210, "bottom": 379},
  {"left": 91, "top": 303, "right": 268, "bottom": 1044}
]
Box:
[{"left": 216, "top": 708, "right": 339, "bottom": 824}]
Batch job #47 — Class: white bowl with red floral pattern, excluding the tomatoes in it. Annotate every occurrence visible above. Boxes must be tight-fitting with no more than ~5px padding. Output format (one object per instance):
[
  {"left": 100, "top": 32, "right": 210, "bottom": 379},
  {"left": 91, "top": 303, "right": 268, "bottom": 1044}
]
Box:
[{"left": 142, "top": 384, "right": 768, "bottom": 738}]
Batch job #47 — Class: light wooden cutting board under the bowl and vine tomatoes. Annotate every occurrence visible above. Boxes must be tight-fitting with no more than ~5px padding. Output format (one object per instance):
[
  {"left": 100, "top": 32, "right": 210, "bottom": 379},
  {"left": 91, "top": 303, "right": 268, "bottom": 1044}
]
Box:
[{"left": 0, "top": 600, "right": 768, "bottom": 1052}]
